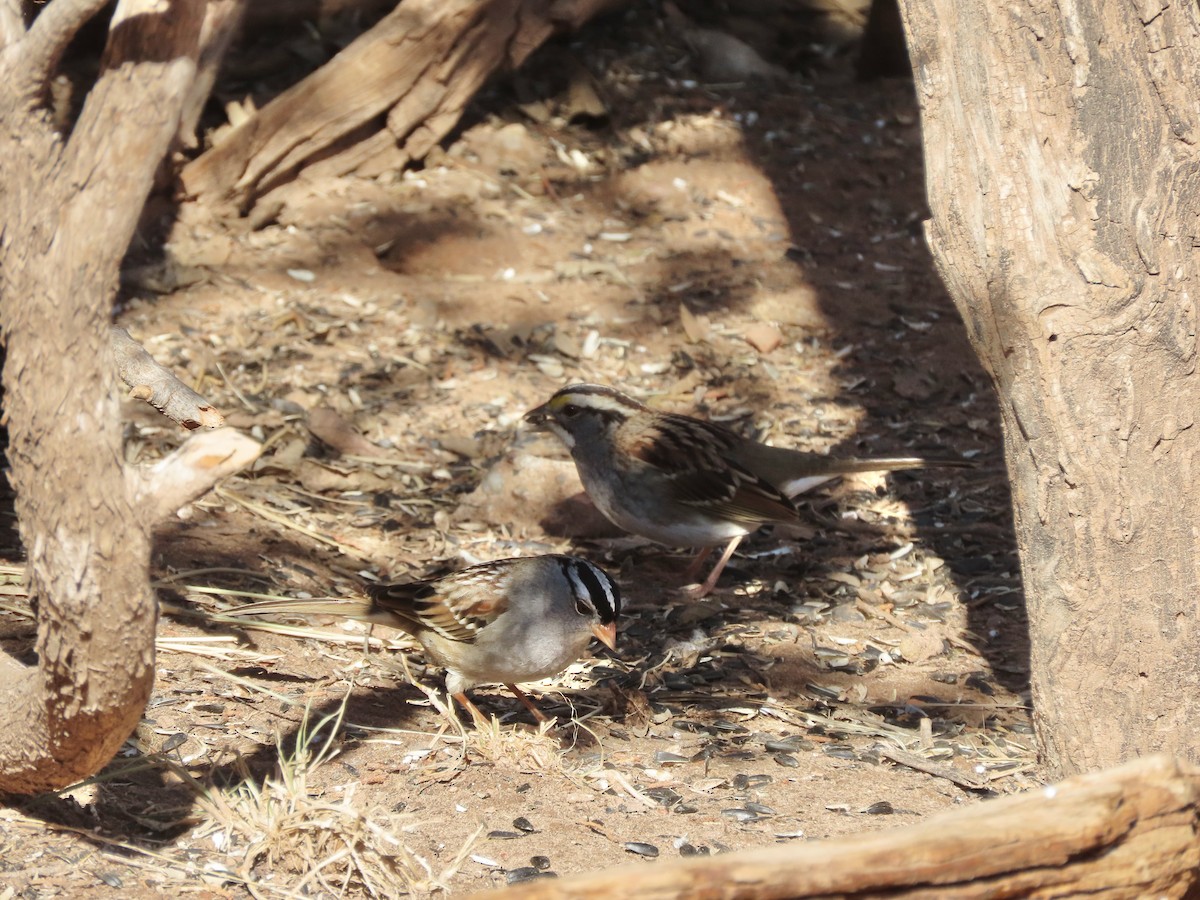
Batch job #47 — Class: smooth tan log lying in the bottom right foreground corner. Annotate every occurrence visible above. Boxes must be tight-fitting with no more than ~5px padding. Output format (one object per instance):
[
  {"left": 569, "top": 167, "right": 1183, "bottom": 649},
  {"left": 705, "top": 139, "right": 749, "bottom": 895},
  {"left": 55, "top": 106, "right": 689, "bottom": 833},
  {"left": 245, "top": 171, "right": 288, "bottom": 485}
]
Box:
[{"left": 475, "top": 756, "right": 1200, "bottom": 900}]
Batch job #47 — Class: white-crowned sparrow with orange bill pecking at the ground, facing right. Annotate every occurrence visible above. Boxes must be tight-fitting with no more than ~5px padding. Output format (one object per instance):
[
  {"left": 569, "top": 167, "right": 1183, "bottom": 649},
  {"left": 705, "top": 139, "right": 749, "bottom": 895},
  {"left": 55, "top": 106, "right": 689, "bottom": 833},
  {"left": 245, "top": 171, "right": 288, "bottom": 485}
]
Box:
[{"left": 226, "top": 556, "right": 620, "bottom": 721}]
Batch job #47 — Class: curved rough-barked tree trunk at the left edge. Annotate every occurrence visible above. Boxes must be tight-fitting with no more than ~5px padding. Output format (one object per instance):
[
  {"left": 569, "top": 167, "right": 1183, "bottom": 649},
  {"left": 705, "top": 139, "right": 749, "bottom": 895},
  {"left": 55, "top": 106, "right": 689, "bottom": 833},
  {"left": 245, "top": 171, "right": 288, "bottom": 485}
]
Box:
[{"left": 0, "top": 0, "right": 260, "bottom": 793}]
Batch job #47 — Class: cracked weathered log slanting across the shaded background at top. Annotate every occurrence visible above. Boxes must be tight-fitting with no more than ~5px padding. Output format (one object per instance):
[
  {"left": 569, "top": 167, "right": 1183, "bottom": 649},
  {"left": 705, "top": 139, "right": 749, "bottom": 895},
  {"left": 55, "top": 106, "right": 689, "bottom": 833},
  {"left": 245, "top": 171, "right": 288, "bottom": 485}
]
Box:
[{"left": 181, "top": 0, "right": 628, "bottom": 209}]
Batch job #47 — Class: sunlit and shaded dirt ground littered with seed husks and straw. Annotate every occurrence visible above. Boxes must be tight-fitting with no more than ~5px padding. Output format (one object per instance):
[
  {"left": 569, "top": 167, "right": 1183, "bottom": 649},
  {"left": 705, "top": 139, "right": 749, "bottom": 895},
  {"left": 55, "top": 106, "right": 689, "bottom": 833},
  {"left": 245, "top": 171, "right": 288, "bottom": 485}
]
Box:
[{"left": 0, "top": 6, "right": 1040, "bottom": 900}]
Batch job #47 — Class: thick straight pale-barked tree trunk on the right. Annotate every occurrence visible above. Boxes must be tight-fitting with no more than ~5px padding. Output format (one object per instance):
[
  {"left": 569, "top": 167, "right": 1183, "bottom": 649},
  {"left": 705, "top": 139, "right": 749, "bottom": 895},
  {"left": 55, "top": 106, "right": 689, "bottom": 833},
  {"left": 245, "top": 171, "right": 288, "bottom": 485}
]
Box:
[{"left": 901, "top": 0, "right": 1200, "bottom": 773}]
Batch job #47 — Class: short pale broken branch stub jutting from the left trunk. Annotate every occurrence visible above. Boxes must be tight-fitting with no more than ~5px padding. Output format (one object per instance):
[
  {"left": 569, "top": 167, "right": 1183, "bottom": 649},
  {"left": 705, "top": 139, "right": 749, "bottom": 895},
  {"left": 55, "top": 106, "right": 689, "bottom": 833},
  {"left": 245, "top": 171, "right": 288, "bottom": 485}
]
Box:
[{"left": 126, "top": 428, "right": 263, "bottom": 523}]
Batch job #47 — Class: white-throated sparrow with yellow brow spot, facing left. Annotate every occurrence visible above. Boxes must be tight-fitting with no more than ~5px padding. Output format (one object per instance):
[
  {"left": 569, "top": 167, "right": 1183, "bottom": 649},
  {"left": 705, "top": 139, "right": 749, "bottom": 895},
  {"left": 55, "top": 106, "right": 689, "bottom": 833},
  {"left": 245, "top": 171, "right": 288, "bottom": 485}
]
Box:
[{"left": 526, "top": 384, "right": 970, "bottom": 596}]
